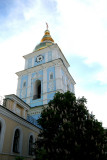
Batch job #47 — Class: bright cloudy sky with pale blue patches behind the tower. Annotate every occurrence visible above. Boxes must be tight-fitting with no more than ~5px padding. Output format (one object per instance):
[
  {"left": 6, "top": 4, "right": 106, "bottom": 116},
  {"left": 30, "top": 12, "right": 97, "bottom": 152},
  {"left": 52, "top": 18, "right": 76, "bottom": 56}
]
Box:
[{"left": 0, "top": 0, "right": 107, "bottom": 128}]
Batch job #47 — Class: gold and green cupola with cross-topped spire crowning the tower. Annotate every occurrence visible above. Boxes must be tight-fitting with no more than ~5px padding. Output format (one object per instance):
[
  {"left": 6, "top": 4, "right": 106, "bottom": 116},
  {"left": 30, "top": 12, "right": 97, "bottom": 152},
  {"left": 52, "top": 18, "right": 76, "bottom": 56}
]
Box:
[{"left": 34, "top": 23, "right": 54, "bottom": 51}]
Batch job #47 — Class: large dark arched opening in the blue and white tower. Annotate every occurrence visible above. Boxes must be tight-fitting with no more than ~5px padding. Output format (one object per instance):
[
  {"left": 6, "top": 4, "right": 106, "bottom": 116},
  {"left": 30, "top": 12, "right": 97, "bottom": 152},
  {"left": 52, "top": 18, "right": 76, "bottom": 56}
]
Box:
[{"left": 33, "top": 80, "right": 41, "bottom": 100}]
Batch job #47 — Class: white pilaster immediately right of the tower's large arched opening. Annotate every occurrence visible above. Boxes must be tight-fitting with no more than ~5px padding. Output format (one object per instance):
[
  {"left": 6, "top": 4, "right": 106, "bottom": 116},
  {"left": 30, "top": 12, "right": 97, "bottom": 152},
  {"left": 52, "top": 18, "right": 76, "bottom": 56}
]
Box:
[{"left": 43, "top": 68, "right": 47, "bottom": 104}]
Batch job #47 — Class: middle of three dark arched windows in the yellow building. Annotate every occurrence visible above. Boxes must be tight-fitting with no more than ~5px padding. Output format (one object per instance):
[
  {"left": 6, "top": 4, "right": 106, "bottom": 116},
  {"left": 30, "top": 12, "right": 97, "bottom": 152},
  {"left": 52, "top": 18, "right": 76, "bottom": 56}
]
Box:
[{"left": 13, "top": 129, "right": 20, "bottom": 153}]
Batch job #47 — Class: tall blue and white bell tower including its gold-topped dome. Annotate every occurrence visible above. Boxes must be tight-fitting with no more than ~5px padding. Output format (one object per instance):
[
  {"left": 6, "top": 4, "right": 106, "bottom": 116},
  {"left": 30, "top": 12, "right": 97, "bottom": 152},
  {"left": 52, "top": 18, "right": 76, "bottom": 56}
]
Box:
[{"left": 16, "top": 27, "right": 75, "bottom": 118}]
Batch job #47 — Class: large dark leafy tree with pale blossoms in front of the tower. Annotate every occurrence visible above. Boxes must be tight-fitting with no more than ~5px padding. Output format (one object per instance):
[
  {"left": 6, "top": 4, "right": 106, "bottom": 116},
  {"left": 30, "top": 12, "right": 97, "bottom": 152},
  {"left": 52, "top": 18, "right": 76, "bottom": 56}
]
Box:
[{"left": 36, "top": 92, "right": 107, "bottom": 160}]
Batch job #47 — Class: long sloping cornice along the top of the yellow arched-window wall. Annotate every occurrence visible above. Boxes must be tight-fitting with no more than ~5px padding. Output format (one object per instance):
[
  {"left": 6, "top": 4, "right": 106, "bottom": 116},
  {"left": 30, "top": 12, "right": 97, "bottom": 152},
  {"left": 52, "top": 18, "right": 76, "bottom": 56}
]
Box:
[{"left": 0, "top": 106, "right": 40, "bottom": 133}]
